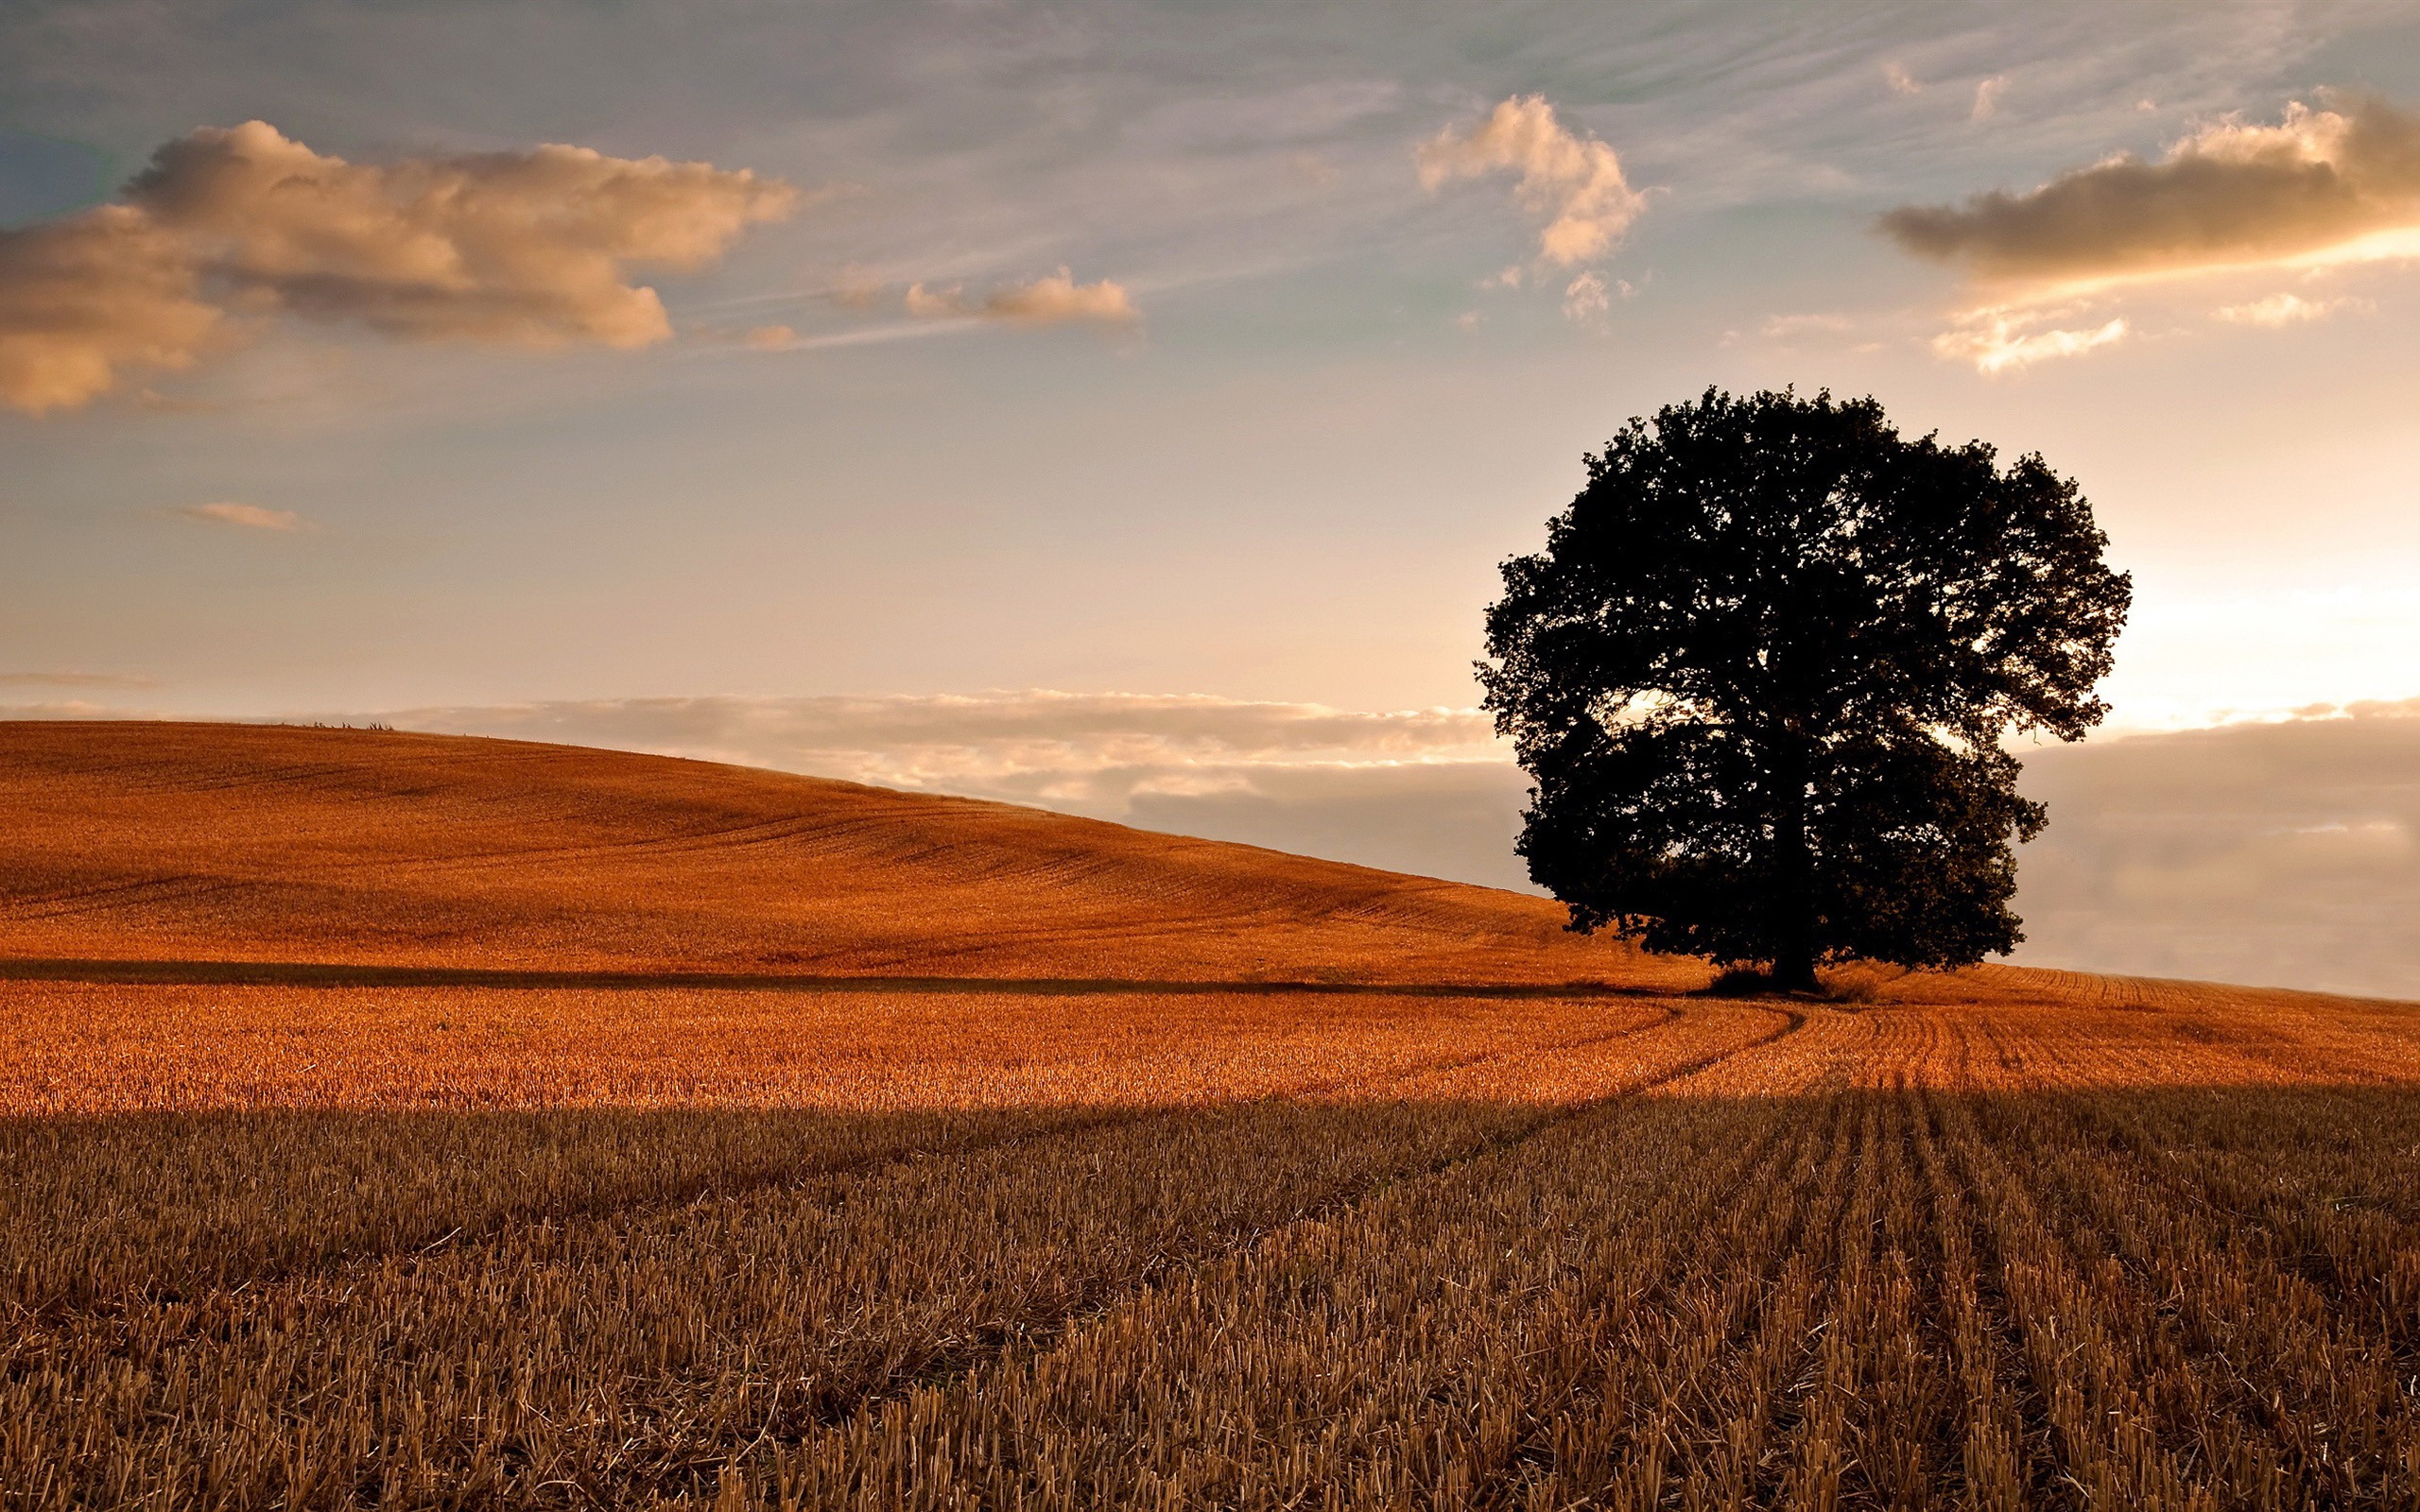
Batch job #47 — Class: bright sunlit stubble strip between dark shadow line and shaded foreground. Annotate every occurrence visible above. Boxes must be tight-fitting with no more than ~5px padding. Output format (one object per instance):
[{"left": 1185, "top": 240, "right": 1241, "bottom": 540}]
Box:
[{"left": 0, "top": 982, "right": 1672, "bottom": 1113}]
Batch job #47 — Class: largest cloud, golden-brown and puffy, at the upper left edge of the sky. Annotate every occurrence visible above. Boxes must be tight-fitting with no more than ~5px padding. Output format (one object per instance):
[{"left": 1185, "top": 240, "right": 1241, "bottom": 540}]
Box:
[{"left": 0, "top": 121, "right": 796, "bottom": 414}]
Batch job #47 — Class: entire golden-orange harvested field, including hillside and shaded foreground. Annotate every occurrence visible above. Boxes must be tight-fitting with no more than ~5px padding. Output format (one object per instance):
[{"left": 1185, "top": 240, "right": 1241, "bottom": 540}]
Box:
[{"left": 0, "top": 723, "right": 2420, "bottom": 1509}]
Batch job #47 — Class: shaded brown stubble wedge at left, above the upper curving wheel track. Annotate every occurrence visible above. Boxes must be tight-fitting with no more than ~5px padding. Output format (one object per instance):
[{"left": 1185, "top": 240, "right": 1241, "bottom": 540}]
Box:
[{"left": 0, "top": 1108, "right": 1098, "bottom": 1318}]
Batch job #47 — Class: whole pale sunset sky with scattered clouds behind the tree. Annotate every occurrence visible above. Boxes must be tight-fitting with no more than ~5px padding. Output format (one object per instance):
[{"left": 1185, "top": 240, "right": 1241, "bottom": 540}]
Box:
[{"left": 0, "top": 0, "right": 2420, "bottom": 992}]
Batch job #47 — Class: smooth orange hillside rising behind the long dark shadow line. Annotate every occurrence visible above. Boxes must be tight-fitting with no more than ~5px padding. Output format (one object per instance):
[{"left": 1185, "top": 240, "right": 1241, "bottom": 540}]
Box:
[{"left": 0, "top": 723, "right": 1703, "bottom": 987}]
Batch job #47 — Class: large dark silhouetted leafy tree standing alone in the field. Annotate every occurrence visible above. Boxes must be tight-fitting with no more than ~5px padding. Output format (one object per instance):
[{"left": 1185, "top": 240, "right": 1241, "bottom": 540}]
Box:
[{"left": 1478, "top": 389, "right": 2132, "bottom": 989}]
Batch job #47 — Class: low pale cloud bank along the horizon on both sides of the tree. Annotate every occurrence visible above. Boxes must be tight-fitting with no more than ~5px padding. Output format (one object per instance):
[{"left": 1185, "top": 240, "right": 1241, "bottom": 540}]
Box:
[{"left": 0, "top": 692, "right": 2420, "bottom": 997}]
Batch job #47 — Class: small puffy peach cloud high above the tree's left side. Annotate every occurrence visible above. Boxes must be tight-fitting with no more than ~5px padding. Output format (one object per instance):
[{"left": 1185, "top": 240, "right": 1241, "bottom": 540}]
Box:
[{"left": 1413, "top": 94, "right": 1646, "bottom": 268}]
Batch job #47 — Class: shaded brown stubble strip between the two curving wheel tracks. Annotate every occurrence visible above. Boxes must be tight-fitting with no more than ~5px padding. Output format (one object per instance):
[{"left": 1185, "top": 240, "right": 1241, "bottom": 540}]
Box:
[{"left": 0, "top": 1103, "right": 1551, "bottom": 1507}]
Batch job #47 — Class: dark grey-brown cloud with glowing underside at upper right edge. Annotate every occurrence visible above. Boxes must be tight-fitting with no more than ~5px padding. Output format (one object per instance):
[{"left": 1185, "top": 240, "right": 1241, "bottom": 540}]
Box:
[{"left": 1880, "top": 96, "right": 2420, "bottom": 288}]
